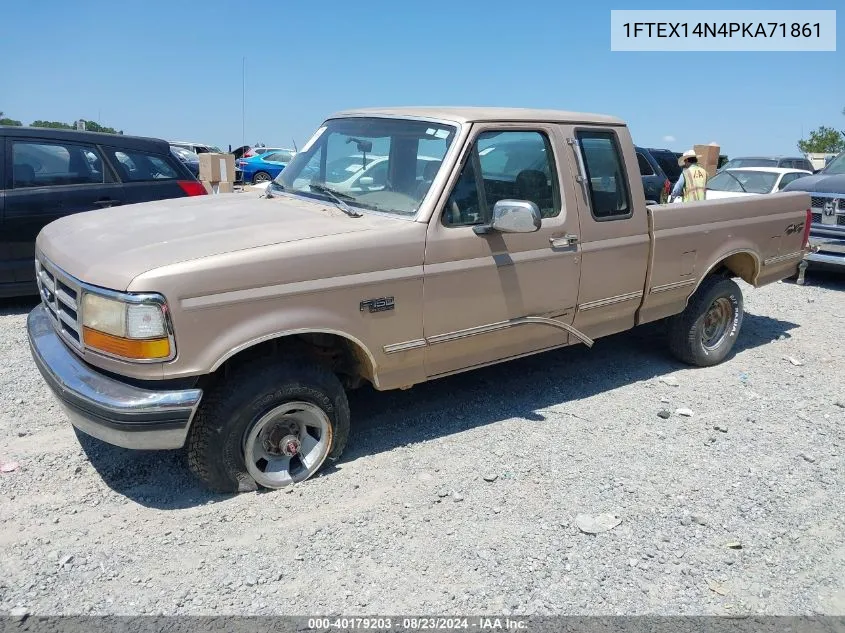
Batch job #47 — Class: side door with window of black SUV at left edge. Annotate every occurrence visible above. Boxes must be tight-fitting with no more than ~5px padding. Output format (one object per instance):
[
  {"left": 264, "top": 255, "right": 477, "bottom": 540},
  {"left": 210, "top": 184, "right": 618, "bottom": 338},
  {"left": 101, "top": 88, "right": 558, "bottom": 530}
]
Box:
[{"left": 4, "top": 137, "right": 122, "bottom": 284}]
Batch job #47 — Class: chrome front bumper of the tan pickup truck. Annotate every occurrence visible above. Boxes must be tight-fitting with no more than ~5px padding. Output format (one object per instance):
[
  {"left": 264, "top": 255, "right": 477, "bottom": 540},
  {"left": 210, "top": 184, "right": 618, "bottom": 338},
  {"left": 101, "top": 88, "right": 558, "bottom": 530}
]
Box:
[{"left": 27, "top": 305, "right": 202, "bottom": 450}]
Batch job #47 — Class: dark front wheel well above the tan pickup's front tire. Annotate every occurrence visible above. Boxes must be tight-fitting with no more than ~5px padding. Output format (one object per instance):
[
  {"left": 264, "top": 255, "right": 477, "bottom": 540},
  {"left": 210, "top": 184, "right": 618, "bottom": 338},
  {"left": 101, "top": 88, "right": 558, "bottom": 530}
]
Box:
[{"left": 216, "top": 332, "right": 375, "bottom": 389}]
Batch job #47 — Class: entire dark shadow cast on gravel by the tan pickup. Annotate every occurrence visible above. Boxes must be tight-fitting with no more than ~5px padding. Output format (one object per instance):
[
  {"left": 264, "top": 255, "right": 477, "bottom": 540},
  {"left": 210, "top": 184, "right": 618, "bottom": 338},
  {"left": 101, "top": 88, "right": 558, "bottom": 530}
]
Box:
[{"left": 78, "top": 313, "right": 798, "bottom": 510}]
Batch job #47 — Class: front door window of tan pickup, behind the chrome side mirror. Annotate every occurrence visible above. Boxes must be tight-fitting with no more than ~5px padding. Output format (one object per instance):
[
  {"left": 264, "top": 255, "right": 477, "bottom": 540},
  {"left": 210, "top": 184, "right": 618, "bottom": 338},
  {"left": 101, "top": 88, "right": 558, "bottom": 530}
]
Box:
[{"left": 442, "top": 130, "right": 561, "bottom": 227}]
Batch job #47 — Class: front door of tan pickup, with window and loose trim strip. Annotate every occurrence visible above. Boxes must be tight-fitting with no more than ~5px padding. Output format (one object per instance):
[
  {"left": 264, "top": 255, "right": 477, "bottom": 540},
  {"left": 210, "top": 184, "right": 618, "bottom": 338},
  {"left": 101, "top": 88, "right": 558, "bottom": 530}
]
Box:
[{"left": 424, "top": 123, "right": 580, "bottom": 377}]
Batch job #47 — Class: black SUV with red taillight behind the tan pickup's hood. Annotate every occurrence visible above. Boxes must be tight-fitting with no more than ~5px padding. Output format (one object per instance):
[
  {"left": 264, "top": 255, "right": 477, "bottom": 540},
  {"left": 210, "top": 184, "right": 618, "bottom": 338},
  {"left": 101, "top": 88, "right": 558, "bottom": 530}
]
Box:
[{"left": 0, "top": 126, "right": 206, "bottom": 297}]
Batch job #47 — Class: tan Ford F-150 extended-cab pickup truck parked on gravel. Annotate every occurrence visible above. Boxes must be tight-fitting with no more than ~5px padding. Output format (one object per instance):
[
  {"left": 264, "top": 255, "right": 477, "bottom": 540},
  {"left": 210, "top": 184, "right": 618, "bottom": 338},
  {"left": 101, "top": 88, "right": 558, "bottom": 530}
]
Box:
[{"left": 28, "top": 108, "right": 810, "bottom": 492}]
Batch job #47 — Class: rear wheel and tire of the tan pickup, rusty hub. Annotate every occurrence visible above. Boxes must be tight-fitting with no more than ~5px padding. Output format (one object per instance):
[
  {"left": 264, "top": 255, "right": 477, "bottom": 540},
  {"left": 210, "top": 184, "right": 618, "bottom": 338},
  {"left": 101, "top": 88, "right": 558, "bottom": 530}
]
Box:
[{"left": 668, "top": 276, "right": 744, "bottom": 367}]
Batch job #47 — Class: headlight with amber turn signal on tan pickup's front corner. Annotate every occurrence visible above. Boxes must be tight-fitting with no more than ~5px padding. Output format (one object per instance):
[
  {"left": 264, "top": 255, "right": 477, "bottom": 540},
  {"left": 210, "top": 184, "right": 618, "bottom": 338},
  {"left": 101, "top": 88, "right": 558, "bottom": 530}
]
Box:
[{"left": 82, "top": 292, "right": 173, "bottom": 360}]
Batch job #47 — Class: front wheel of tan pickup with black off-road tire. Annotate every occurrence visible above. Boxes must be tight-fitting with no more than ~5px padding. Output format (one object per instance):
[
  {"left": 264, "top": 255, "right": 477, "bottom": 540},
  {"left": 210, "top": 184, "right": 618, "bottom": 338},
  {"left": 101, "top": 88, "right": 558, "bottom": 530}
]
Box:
[{"left": 187, "top": 360, "right": 350, "bottom": 493}]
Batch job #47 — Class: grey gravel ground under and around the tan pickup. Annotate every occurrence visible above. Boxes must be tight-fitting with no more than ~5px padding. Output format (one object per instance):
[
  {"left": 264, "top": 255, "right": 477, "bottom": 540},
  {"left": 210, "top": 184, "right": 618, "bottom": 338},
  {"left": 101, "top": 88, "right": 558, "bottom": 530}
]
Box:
[{"left": 0, "top": 274, "right": 845, "bottom": 615}]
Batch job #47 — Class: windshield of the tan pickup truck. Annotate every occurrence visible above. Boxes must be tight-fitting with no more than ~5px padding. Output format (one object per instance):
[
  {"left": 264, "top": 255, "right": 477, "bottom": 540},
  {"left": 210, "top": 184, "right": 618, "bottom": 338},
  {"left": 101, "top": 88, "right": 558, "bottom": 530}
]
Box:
[{"left": 270, "top": 117, "right": 457, "bottom": 216}]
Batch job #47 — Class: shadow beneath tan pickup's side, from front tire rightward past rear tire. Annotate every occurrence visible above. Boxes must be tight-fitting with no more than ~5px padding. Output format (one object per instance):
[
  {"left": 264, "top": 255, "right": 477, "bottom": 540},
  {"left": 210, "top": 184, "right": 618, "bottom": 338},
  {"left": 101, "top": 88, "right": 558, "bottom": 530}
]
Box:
[{"left": 341, "top": 313, "right": 798, "bottom": 462}]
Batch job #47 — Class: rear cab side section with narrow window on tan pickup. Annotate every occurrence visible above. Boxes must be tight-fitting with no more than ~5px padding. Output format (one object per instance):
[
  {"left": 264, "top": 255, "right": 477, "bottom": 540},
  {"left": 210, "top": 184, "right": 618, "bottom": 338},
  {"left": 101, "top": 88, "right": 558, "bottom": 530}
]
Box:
[{"left": 561, "top": 126, "right": 651, "bottom": 337}]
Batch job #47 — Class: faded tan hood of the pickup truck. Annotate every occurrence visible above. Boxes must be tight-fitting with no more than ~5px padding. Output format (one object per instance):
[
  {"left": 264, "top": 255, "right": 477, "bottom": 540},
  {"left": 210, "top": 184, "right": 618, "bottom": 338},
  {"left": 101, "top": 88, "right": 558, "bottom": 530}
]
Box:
[{"left": 36, "top": 193, "right": 376, "bottom": 290}]
